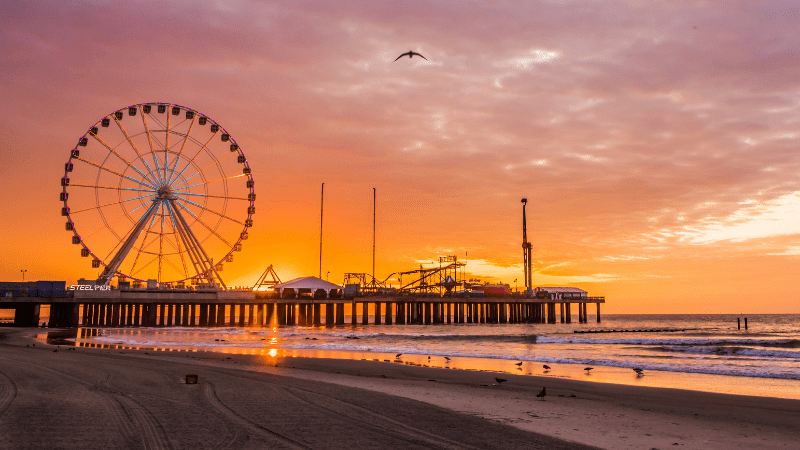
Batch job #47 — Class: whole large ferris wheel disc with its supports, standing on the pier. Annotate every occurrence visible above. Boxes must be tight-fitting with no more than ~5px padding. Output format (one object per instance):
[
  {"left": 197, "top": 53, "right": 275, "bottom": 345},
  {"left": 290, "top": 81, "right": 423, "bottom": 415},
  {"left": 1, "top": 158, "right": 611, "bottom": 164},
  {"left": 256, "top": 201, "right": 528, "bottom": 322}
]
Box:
[{"left": 59, "top": 103, "right": 256, "bottom": 288}]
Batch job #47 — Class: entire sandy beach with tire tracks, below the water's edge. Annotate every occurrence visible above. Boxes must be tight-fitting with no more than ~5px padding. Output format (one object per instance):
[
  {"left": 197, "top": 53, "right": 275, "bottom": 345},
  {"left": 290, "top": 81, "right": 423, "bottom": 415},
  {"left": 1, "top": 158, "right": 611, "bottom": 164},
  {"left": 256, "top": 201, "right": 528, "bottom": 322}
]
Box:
[{"left": 0, "top": 328, "right": 800, "bottom": 449}]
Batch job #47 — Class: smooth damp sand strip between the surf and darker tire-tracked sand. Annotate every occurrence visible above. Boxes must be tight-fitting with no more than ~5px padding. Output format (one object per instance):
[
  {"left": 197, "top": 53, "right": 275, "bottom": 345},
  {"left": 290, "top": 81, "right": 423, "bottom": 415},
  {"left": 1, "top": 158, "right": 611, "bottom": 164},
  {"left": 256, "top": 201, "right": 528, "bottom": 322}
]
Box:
[{"left": 6, "top": 330, "right": 800, "bottom": 449}]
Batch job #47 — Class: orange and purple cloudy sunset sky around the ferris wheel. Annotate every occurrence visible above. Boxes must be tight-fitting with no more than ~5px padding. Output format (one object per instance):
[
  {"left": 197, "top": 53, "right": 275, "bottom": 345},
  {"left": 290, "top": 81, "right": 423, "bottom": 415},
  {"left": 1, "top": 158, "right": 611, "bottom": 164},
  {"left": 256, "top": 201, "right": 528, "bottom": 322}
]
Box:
[{"left": 0, "top": 1, "right": 800, "bottom": 313}]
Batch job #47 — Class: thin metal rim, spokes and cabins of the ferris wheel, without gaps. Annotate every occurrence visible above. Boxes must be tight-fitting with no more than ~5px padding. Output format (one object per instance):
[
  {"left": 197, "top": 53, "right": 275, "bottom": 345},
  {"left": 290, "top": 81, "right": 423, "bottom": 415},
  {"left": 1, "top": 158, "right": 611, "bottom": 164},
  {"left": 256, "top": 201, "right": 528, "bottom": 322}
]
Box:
[{"left": 60, "top": 102, "right": 255, "bottom": 283}]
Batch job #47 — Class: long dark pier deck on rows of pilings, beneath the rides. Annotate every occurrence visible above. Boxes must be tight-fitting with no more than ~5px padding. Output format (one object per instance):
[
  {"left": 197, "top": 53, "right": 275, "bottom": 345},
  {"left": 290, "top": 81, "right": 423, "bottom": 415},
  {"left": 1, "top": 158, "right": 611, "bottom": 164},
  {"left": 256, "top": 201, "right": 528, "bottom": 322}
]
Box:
[{"left": 0, "top": 289, "right": 605, "bottom": 327}]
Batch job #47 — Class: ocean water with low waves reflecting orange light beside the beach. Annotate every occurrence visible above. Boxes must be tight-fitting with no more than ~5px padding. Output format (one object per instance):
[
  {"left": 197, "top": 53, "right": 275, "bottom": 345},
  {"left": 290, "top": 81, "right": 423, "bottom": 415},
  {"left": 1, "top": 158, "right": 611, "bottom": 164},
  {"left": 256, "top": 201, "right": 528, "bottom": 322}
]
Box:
[{"left": 73, "top": 314, "right": 800, "bottom": 398}]
